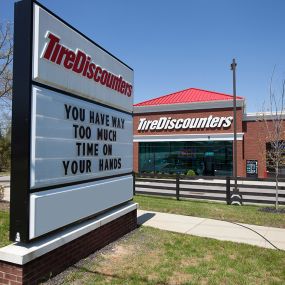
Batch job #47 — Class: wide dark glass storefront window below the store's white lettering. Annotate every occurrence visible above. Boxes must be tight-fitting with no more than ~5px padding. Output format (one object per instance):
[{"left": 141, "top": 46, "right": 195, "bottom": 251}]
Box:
[{"left": 139, "top": 141, "right": 233, "bottom": 176}]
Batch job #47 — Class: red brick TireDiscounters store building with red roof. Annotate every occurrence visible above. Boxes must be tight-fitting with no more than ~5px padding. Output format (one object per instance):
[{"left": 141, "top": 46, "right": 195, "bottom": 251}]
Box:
[{"left": 134, "top": 88, "right": 282, "bottom": 177}]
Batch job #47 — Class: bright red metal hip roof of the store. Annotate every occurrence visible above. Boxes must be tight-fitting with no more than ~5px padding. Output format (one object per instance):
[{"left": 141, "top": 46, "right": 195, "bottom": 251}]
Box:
[{"left": 134, "top": 88, "right": 244, "bottom": 107}]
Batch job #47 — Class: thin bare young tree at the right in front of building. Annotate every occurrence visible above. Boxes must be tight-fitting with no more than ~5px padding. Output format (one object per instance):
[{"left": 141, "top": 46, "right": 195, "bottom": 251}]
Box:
[{"left": 259, "top": 72, "right": 285, "bottom": 210}]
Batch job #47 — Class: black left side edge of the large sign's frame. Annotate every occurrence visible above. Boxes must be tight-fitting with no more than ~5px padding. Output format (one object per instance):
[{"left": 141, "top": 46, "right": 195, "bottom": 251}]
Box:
[{"left": 9, "top": 0, "right": 34, "bottom": 242}]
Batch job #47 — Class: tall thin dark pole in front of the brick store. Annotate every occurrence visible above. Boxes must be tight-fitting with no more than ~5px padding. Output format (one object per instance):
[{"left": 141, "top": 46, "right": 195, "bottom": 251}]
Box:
[{"left": 231, "top": 59, "right": 242, "bottom": 205}]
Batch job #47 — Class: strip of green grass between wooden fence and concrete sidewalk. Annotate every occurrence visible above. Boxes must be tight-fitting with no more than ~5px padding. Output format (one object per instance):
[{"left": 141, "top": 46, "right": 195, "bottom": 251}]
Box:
[{"left": 134, "top": 195, "right": 285, "bottom": 228}]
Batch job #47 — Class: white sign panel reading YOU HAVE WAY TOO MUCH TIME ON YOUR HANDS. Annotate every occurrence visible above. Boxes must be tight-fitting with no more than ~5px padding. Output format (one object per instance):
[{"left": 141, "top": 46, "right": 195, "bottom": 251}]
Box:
[{"left": 31, "top": 86, "right": 133, "bottom": 189}]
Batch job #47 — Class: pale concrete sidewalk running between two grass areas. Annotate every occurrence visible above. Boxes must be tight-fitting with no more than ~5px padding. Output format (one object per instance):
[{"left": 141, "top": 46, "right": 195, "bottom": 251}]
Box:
[{"left": 138, "top": 210, "right": 285, "bottom": 250}]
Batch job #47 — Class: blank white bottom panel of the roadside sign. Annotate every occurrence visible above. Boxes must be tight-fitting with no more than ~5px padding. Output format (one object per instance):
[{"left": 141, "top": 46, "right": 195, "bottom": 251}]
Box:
[{"left": 29, "top": 175, "right": 133, "bottom": 238}]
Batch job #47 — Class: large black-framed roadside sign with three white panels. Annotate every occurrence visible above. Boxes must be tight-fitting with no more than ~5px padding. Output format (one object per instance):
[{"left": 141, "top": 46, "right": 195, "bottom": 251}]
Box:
[{"left": 10, "top": 2, "right": 133, "bottom": 242}]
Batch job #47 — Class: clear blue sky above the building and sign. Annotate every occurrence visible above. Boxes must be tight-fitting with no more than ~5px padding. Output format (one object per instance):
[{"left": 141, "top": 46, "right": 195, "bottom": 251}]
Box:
[{"left": 0, "top": 0, "right": 285, "bottom": 112}]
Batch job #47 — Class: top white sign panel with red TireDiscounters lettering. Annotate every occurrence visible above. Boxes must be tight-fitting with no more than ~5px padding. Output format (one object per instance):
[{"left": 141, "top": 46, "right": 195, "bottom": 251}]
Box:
[{"left": 33, "top": 4, "right": 133, "bottom": 112}]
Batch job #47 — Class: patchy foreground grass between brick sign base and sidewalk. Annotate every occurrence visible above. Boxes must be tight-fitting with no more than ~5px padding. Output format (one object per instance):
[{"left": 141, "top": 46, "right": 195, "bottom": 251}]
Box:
[{"left": 47, "top": 227, "right": 285, "bottom": 285}]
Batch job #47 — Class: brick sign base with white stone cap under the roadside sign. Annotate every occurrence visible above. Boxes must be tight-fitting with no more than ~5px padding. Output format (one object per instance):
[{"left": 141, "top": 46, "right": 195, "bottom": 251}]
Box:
[{"left": 0, "top": 202, "right": 138, "bottom": 285}]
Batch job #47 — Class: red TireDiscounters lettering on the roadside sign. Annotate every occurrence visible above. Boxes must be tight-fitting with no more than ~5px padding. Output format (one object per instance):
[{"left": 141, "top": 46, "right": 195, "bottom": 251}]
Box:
[{"left": 41, "top": 32, "right": 133, "bottom": 97}]
